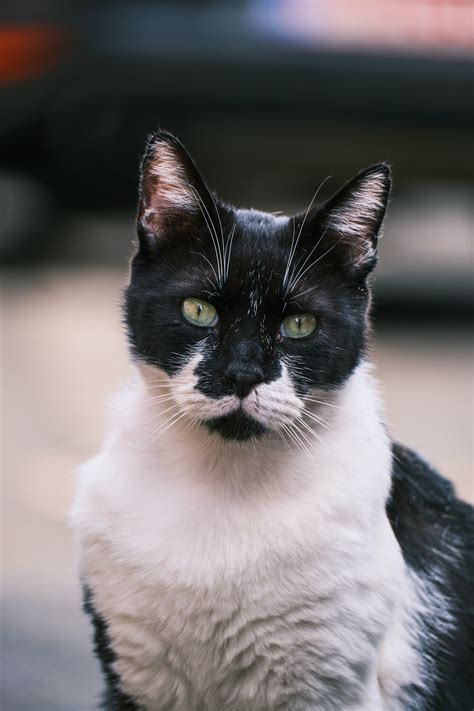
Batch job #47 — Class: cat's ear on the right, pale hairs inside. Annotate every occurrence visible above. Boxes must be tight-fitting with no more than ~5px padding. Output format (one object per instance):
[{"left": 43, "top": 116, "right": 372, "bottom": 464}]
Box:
[{"left": 318, "top": 163, "right": 392, "bottom": 274}]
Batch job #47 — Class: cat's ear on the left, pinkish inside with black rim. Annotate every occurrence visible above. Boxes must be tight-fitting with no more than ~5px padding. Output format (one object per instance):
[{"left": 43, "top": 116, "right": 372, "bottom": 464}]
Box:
[{"left": 137, "top": 131, "right": 217, "bottom": 247}]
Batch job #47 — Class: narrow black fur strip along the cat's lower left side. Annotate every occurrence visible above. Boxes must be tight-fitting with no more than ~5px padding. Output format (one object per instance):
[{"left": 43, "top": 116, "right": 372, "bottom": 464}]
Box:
[{"left": 82, "top": 585, "right": 140, "bottom": 711}]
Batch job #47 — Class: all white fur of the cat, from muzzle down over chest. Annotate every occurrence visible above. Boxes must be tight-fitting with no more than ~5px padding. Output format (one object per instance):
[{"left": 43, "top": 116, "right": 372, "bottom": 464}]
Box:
[{"left": 72, "top": 364, "right": 422, "bottom": 711}]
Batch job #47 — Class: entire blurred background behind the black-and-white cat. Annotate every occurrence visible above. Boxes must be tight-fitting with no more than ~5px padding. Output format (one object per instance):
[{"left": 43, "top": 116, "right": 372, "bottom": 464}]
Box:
[{"left": 0, "top": 0, "right": 474, "bottom": 711}]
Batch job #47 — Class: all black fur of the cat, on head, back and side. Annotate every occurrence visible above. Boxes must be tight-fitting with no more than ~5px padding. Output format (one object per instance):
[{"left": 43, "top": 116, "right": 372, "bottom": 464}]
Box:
[{"left": 84, "top": 132, "right": 474, "bottom": 711}]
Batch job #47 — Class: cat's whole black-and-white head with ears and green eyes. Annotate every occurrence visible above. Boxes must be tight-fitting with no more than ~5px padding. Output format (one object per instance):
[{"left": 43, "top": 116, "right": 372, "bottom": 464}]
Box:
[{"left": 125, "top": 132, "right": 390, "bottom": 440}]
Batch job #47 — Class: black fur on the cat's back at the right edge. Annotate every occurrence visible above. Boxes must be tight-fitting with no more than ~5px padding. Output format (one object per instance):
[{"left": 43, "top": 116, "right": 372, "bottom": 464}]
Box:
[{"left": 387, "top": 444, "right": 474, "bottom": 711}]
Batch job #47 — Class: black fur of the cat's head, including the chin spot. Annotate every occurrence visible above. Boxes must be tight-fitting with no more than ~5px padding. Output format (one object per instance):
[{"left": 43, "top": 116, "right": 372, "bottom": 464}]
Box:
[{"left": 125, "top": 132, "right": 390, "bottom": 439}]
